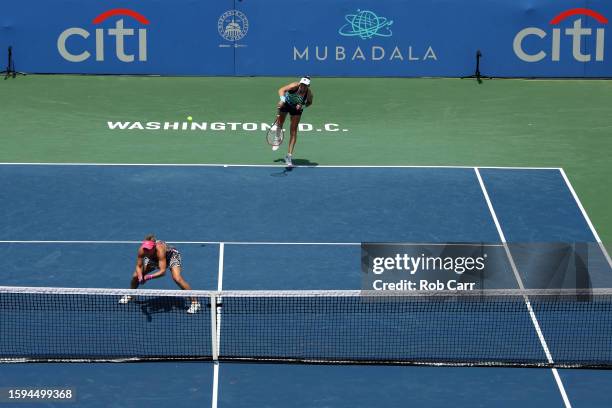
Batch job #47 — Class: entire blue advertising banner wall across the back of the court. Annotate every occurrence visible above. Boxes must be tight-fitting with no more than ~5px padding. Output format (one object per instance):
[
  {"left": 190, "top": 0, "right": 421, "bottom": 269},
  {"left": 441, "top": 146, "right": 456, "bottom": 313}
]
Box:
[{"left": 0, "top": 0, "right": 612, "bottom": 77}]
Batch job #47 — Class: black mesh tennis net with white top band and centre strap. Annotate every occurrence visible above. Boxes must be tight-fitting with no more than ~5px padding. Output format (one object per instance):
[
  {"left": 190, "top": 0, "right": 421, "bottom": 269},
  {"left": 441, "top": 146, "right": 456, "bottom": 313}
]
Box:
[{"left": 0, "top": 287, "right": 612, "bottom": 367}]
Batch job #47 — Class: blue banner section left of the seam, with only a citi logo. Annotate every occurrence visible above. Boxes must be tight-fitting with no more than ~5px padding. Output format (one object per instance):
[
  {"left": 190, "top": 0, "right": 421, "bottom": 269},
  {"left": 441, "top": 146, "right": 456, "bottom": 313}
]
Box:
[{"left": 0, "top": 0, "right": 234, "bottom": 75}]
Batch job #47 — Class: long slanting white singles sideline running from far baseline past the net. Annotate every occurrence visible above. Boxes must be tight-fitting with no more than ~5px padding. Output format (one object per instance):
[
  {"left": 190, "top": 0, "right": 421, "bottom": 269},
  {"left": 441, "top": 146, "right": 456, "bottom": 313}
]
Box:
[{"left": 474, "top": 167, "right": 572, "bottom": 408}]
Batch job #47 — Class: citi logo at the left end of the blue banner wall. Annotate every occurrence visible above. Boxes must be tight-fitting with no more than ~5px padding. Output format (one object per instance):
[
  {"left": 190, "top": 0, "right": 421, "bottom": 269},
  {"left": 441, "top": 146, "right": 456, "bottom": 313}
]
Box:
[{"left": 57, "top": 9, "right": 149, "bottom": 62}]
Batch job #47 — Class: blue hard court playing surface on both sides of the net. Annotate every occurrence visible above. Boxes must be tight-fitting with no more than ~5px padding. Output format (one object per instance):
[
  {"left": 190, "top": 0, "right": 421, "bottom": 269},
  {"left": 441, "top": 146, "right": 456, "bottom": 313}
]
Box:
[{"left": 0, "top": 165, "right": 612, "bottom": 408}]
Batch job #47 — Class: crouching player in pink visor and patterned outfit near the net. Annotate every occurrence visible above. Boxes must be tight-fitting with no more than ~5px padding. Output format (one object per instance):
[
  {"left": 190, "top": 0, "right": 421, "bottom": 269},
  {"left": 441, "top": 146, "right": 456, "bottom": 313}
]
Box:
[{"left": 119, "top": 235, "right": 201, "bottom": 314}]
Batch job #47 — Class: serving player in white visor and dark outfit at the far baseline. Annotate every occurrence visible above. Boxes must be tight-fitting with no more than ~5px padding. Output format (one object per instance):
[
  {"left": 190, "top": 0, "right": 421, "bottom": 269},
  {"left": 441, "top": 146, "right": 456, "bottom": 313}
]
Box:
[{"left": 272, "top": 76, "right": 313, "bottom": 166}]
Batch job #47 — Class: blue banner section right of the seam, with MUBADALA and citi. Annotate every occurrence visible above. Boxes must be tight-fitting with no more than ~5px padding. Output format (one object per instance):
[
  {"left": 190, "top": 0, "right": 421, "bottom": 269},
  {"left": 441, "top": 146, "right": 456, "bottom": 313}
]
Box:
[{"left": 236, "top": 0, "right": 612, "bottom": 77}]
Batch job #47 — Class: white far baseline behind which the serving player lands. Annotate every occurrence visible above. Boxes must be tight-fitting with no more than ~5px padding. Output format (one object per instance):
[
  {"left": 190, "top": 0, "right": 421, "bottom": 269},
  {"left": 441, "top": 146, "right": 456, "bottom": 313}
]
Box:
[{"left": 0, "top": 162, "right": 560, "bottom": 170}]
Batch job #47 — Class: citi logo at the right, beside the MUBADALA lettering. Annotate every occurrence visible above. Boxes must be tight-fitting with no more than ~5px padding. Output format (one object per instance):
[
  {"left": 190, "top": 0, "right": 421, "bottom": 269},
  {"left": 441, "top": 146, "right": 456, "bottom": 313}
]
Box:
[{"left": 513, "top": 8, "right": 608, "bottom": 62}]
